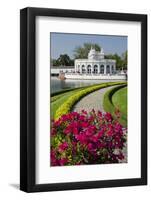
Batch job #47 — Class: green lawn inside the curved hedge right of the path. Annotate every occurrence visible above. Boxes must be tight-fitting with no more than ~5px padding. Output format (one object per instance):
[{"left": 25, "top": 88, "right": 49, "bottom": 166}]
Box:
[{"left": 112, "top": 87, "right": 127, "bottom": 118}]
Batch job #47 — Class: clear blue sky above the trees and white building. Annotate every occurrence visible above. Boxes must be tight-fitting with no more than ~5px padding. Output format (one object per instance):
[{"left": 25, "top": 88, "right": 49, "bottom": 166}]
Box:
[{"left": 50, "top": 33, "right": 127, "bottom": 59}]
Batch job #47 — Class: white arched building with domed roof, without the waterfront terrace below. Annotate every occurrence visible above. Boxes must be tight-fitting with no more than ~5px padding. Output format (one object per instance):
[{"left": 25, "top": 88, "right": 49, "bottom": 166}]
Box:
[{"left": 75, "top": 47, "right": 116, "bottom": 75}]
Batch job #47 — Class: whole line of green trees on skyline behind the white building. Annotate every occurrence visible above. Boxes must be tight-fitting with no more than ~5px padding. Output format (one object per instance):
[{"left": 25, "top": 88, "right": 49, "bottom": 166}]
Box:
[{"left": 52, "top": 43, "right": 127, "bottom": 69}]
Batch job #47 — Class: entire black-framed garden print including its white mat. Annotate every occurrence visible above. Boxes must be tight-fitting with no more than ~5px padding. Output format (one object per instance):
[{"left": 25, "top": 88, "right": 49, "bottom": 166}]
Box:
[{"left": 20, "top": 8, "right": 147, "bottom": 192}]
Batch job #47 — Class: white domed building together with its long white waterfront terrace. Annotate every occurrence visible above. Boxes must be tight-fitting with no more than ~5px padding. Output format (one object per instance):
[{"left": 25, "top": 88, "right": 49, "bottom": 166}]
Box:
[{"left": 65, "top": 47, "right": 126, "bottom": 80}]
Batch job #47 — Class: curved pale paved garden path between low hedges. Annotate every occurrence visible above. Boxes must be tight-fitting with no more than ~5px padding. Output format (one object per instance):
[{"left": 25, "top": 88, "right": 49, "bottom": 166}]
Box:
[{"left": 73, "top": 85, "right": 117, "bottom": 112}]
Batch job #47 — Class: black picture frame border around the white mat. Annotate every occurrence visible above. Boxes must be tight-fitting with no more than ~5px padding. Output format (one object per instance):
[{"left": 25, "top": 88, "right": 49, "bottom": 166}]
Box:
[{"left": 20, "top": 7, "right": 147, "bottom": 192}]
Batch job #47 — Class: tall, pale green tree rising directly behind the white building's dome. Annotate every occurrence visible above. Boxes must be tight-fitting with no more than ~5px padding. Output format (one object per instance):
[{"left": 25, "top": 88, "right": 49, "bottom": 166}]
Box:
[{"left": 74, "top": 43, "right": 101, "bottom": 59}]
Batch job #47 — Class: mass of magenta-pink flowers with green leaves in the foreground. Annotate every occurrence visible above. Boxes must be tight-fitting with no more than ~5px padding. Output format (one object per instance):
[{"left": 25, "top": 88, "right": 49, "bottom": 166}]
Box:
[{"left": 51, "top": 110, "right": 126, "bottom": 166}]
